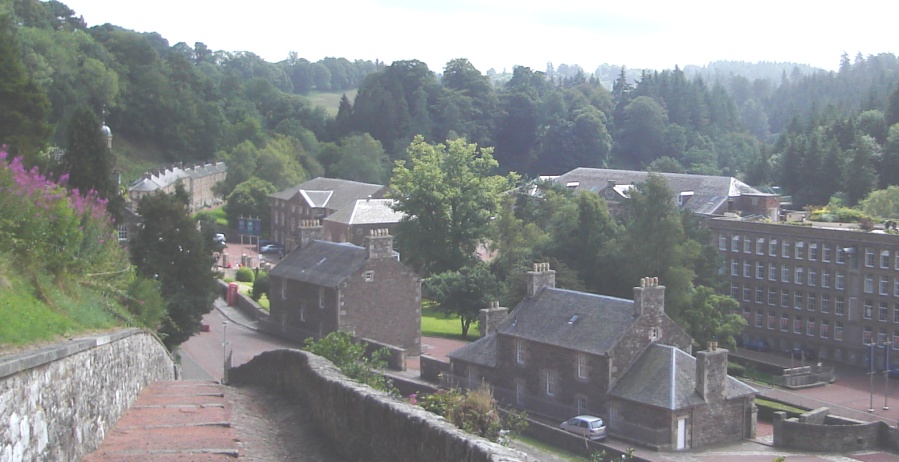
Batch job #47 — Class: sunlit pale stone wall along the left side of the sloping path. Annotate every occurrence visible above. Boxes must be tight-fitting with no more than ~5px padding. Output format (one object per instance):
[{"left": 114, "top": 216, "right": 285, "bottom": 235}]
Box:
[{"left": 0, "top": 329, "right": 175, "bottom": 462}]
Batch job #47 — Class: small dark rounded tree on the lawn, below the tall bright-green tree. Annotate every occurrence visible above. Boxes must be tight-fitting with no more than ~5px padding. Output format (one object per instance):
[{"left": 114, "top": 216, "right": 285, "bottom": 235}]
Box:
[{"left": 424, "top": 261, "right": 499, "bottom": 338}]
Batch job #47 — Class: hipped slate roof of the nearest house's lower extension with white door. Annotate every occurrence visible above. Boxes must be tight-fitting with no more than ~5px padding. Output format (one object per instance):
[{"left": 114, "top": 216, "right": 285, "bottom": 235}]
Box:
[{"left": 609, "top": 343, "right": 757, "bottom": 410}]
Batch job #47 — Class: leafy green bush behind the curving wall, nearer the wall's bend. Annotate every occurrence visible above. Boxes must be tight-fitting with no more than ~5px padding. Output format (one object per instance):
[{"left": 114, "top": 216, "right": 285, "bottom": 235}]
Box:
[{"left": 305, "top": 331, "right": 397, "bottom": 395}]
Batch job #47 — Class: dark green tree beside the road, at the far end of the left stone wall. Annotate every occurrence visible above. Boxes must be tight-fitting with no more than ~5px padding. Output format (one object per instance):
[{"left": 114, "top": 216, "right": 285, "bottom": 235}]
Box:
[{"left": 129, "top": 188, "right": 216, "bottom": 348}]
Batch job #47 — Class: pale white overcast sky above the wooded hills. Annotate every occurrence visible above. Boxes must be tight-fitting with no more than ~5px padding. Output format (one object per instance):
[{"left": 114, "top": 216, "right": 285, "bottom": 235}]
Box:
[{"left": 63, "top": 0, "right": 899, "bottom": 72}]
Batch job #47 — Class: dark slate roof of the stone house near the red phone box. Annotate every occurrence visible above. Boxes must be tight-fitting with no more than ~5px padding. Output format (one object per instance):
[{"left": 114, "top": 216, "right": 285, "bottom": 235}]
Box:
[{"left": 269, "top": 240, "right": 368, "bottom": 287}]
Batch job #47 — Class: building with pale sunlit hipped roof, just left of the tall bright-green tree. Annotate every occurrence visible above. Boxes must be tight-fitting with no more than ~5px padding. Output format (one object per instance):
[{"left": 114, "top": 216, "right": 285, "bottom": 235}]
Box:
[{"left": 322, "top": 198, "right": 405, "bottom": 245}]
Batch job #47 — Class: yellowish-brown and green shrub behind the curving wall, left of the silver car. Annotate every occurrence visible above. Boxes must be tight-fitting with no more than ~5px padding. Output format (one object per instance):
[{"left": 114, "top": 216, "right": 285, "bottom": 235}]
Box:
[{"left": 418, "top": 385, "right": 527, "bottom": 442}]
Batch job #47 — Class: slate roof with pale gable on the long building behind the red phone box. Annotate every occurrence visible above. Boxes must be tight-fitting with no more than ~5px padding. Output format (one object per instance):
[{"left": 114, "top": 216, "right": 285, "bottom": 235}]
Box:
[{"left": 271, "top": 177, "right": 387, "bottom": 210}]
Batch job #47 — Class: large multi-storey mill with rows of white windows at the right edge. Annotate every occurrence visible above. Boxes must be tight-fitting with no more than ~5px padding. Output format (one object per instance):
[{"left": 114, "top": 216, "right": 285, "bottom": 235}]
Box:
[{"left": 706, "top": 218, "right": 899, "bottom": 365}]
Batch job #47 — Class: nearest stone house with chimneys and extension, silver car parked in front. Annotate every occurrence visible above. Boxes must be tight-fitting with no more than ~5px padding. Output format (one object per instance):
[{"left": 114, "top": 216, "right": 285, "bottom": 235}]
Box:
[{"left": 449, "top": 264, "right": 754, "bottom": 448}]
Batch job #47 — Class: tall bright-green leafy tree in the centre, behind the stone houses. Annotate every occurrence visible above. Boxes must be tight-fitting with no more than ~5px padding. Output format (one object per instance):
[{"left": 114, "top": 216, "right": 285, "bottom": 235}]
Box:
[{"left": 390, "top": 136, "right": 517, "bottom": 275}]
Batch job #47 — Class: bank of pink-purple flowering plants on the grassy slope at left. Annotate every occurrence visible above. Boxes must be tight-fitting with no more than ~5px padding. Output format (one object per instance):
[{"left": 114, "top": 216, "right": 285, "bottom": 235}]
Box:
[{"left": 0, "top": 147, "right": 115, "bottom": 274}]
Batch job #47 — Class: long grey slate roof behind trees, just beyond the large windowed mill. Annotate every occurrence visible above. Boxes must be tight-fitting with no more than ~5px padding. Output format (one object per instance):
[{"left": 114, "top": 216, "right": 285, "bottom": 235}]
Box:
[{"left": 554, "top": 167, "right": 775, "bottom": 215}]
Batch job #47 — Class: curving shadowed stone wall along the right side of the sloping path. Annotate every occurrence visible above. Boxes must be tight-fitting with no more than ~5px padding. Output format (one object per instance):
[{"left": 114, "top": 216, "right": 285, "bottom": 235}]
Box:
[{"left": 230, "top": 350, "right": 525, "bottom": 462}]
